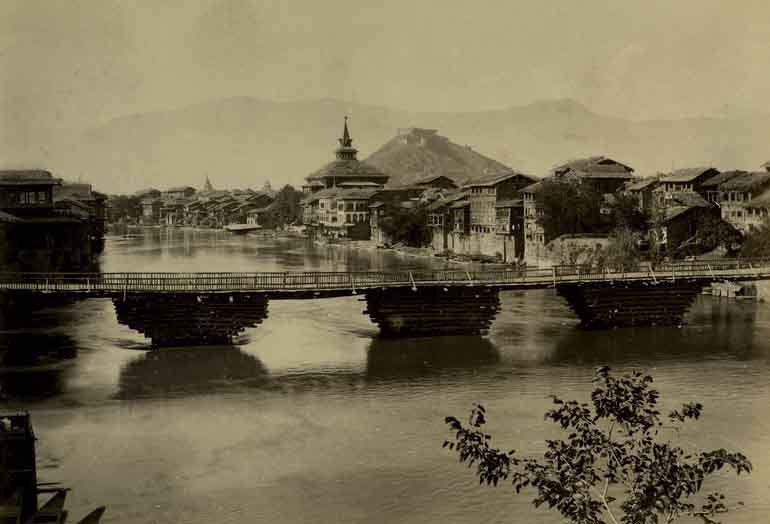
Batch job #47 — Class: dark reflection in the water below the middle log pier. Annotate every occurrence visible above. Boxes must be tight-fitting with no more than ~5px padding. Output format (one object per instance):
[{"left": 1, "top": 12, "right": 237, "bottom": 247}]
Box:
[{"left": 366, "top": 336, "right": 500, "bottom": 381}]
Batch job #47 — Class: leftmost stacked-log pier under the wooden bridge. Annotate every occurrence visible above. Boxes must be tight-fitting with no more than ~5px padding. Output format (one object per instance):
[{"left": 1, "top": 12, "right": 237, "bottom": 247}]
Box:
[{"left": 112, "top": 293, "right": 268, "bottom": 347}]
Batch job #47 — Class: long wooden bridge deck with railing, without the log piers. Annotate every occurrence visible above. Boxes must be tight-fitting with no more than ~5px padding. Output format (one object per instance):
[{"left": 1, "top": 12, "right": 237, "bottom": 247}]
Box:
[{"left": 0, "top": 259, "right": 770, "bottom": 298}]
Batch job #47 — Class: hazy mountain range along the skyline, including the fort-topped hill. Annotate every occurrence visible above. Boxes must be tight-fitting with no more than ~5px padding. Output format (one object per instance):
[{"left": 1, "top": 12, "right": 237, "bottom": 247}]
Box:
[{"left": 0, "top": 97, "right": 770, "bottom": 193}]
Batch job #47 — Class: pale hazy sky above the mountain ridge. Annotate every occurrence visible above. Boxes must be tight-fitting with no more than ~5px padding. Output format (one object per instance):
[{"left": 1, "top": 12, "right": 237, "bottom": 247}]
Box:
[{"left": 0, "top": 0, "right": 770, "bottom": 132}]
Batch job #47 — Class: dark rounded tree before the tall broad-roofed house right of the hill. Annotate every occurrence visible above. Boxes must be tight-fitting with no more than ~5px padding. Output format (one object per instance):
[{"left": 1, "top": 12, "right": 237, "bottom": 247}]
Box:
[{"left": 537, "top": 178, "right": 606, "bottom": 239}]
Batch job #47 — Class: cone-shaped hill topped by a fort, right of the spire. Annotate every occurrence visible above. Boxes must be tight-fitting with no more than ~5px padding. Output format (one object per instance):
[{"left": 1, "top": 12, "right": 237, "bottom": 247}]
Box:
[{"left": 366, "top": 128, "right": 510, "bottom": 186}]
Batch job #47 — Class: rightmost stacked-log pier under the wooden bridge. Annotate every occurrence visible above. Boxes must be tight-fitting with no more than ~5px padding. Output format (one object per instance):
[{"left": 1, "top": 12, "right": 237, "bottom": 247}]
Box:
[{"left": 556, "top": 280, "right": 704, "bottom": 329}]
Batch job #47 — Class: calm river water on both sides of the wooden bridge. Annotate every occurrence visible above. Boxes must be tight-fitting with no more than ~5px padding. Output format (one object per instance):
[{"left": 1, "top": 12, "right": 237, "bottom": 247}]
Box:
[{"left": 0, "top": 230, "right": 770, "bottom": 524}]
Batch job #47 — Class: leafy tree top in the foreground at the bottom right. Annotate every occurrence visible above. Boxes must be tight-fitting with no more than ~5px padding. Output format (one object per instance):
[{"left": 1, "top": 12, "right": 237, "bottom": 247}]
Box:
[{"left": 444, "top": 367, "right": 751, "bottom": 524}]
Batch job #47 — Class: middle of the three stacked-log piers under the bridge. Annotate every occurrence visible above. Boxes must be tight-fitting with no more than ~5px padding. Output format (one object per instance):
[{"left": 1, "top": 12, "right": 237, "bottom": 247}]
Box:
[{"left": 364, "top": 286, "right": 500, "bottom": 337}]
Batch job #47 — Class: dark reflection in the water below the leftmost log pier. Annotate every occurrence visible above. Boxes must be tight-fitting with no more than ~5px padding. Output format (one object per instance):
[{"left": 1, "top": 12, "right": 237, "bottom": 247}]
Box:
[{"left": 116, "top": 346, "right": 267, "bottom": 399}]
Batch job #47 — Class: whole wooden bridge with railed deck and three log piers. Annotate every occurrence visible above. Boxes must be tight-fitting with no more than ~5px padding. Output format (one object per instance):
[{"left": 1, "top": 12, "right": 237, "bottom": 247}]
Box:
[{"left": 0, "top": 259, "right": 770, "bottom": 345}]
